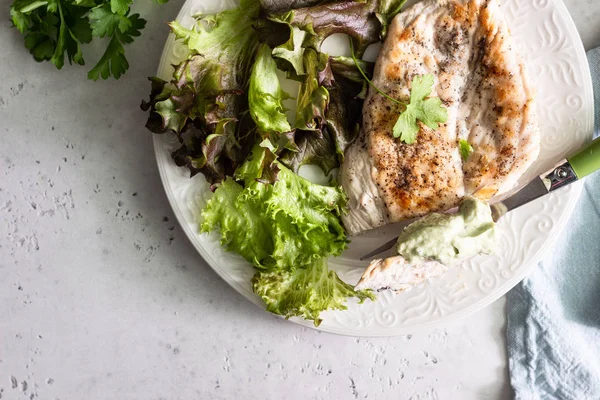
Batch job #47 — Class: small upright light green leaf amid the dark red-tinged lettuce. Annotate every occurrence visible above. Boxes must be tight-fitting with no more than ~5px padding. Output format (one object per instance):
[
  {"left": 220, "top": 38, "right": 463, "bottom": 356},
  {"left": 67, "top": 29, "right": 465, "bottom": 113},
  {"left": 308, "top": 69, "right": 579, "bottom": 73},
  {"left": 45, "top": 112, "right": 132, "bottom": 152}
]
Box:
[{"left": 248, "top": 44, "right": 292, "bottom": 132}]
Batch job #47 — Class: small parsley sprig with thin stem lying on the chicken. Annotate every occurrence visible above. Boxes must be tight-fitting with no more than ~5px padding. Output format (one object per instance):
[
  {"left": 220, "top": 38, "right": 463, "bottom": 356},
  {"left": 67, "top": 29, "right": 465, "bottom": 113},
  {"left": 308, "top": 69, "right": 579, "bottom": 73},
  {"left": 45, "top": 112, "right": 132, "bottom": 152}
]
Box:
[{"left": 350, "top": 41, "right": 448, "bottom": 144}]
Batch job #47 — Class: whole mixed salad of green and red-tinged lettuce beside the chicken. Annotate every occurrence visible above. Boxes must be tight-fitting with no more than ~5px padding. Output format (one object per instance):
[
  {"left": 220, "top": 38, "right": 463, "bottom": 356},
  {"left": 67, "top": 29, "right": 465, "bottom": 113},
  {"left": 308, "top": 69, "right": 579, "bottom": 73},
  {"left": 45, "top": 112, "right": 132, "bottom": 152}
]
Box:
[{"left": 142, "top": 0, "right": 405, "bottom": 325}]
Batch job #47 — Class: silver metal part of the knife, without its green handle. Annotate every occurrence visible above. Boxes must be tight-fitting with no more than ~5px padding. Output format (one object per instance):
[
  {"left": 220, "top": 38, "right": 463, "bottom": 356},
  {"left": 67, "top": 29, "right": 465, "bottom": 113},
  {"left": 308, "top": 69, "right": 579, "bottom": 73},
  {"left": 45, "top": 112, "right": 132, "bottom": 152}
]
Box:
[{"left": 360, "top": 160, "right": 577, "bottom": 261}]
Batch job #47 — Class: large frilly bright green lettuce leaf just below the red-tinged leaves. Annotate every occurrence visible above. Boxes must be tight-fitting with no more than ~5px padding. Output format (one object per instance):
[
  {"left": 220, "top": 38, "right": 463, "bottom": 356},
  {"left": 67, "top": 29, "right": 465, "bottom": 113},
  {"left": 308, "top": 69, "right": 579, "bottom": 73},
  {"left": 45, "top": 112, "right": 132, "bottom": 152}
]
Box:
[{"left": 201, "top": 148, "right": 347, "bottom": 269}]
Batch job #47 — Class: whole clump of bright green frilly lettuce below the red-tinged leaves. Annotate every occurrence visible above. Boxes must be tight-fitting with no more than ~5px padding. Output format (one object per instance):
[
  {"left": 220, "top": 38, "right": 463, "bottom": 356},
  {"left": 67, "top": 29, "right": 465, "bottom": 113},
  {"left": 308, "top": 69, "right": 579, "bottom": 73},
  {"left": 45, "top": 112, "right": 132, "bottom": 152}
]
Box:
[{"left": 200, "top": 146, "right": 372, "bottom": 325}]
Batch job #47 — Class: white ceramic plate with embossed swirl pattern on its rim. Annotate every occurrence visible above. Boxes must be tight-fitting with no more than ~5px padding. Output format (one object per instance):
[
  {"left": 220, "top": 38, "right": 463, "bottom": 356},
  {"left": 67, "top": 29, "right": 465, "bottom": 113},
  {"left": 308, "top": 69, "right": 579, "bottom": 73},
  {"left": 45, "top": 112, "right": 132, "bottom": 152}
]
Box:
[{"left": 154, "top": 0, "right": 593, "bottom": 336}]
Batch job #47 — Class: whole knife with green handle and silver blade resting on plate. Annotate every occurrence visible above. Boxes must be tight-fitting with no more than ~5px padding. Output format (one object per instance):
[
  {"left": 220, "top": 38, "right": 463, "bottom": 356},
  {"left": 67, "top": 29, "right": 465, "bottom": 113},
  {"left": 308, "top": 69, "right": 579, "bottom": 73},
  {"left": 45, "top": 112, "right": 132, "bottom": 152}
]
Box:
[{"left": 360, "top": 137, "right": 600, "bottom": 261}]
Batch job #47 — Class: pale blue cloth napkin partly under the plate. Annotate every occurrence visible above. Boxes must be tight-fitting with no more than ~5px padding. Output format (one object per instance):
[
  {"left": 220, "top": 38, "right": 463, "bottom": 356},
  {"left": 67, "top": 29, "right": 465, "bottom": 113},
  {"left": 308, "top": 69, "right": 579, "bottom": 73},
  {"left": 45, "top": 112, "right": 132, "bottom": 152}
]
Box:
[{"left": 507, "top": 48, "right": 600, "bottom": 400}]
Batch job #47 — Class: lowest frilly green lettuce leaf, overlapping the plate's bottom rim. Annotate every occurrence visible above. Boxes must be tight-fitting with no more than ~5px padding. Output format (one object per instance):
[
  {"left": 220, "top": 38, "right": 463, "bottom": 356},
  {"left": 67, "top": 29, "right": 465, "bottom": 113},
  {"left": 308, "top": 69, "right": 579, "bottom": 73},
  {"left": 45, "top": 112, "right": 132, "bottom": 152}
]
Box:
[{"left": 252, "top": 258, "right": 375, "bottom": 326}]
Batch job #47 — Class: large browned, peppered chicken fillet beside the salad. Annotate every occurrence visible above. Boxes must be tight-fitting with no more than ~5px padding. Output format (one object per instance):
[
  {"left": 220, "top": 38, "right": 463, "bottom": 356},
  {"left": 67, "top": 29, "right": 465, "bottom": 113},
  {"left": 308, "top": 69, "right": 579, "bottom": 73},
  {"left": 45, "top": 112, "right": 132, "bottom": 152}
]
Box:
[{"left": 340, "top": 0, "right": 540, "bottom": 234}]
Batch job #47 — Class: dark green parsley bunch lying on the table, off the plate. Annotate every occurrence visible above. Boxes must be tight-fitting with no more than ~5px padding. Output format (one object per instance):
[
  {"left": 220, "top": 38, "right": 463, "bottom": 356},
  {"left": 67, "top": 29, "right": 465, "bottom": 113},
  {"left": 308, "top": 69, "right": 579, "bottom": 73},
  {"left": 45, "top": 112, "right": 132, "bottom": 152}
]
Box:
[{"left": 10, "top": 0, "right": 159, "bottom": 80}]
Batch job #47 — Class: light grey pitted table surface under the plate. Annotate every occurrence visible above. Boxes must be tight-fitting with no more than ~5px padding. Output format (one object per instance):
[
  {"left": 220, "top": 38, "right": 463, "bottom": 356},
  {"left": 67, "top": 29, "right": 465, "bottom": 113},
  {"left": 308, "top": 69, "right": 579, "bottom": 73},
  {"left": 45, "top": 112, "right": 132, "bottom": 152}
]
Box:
[{"left": 0, "top": 0, "right": 600, "bottom": 400}]
